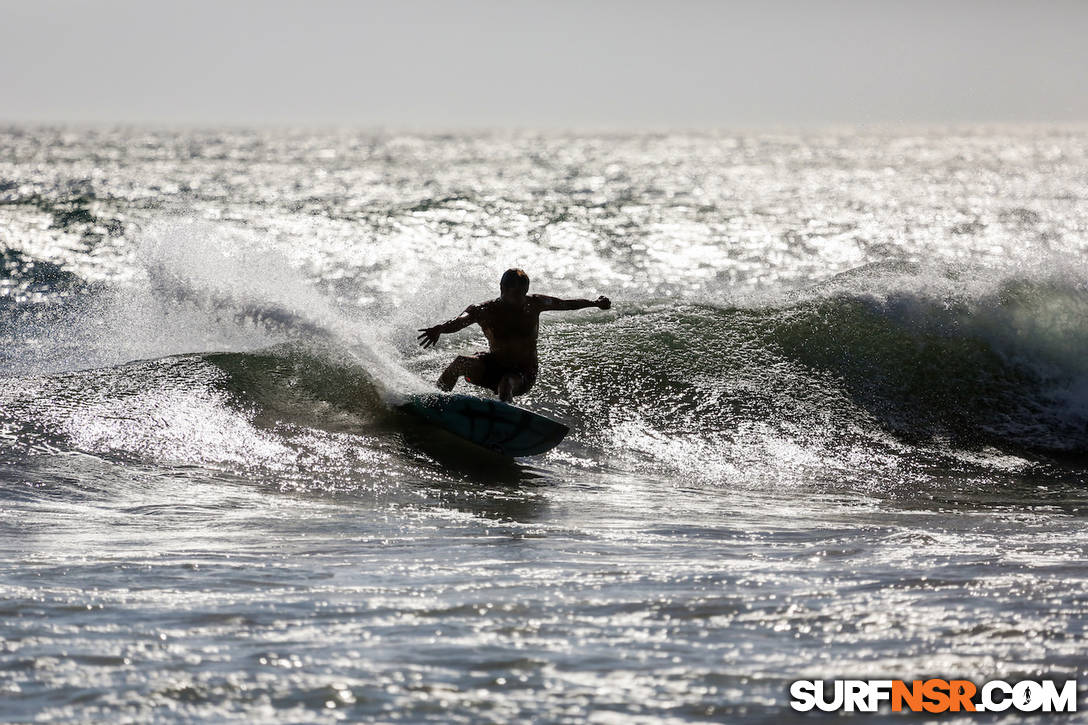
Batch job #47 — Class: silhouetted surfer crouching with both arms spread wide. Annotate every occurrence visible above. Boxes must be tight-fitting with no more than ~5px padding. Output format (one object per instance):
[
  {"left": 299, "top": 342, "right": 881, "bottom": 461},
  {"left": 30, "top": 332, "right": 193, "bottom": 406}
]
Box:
[{"left": 419, "top": 269, "right": 611, "bottom": 403}]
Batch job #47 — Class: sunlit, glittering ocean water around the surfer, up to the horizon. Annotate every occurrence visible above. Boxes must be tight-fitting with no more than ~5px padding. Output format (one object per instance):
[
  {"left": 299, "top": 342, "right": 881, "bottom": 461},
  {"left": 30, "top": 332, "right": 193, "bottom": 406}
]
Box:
[{"left": 0, "top": 126, "right": 1088, "bottom": 723}]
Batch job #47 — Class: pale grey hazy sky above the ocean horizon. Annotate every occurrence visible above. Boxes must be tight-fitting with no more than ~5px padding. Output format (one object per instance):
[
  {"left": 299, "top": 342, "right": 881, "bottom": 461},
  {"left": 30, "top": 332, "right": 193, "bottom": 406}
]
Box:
[{"left": 0, "top": 0, "right": 1088, "bottom": 128}]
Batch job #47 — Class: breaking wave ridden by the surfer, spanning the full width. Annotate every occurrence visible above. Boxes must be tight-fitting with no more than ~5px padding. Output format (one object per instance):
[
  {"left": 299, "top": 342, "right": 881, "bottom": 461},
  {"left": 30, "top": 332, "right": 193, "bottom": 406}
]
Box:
[{"left": 0, "top": 265, "right": 1088, "bottom": 480}]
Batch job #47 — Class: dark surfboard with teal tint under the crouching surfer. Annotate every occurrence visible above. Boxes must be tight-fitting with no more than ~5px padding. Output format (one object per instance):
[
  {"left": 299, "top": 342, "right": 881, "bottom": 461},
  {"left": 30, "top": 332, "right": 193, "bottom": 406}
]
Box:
[{"left": 399, "top": 393, "right": 570, "bottom": 457}]
